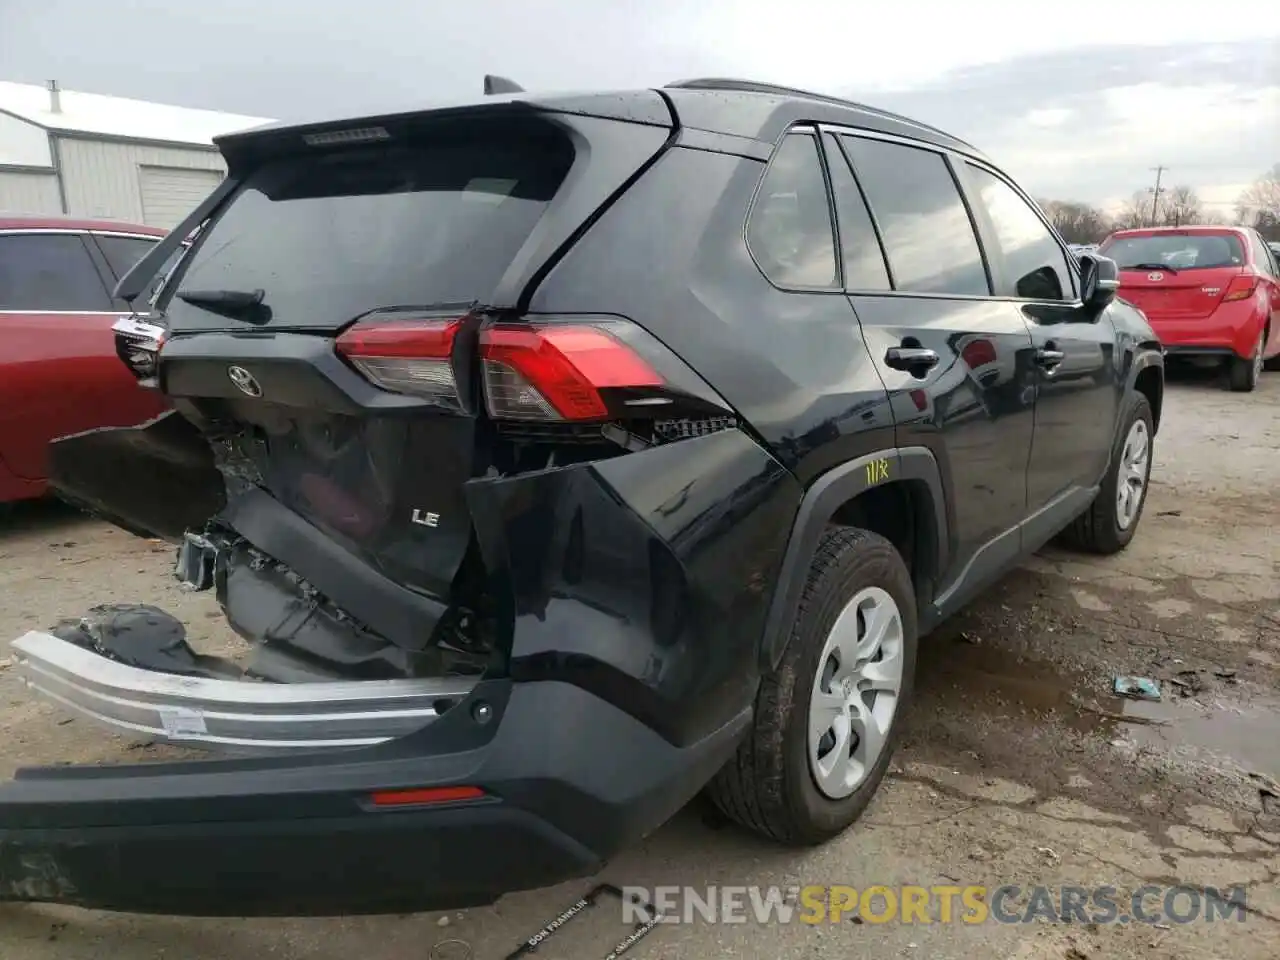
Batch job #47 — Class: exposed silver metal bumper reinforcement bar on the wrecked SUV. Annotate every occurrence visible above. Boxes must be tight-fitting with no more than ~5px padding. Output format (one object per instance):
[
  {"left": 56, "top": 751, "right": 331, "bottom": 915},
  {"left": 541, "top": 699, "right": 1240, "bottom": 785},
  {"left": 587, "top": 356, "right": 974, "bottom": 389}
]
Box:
[{"left": 13, "top": 630, "right": 475, "bottom": 750}]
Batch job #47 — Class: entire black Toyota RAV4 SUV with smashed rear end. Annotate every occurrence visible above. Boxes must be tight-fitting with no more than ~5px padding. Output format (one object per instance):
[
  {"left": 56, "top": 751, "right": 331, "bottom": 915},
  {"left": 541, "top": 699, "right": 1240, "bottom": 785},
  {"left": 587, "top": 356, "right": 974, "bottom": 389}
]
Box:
[{"left": 0, "top": 81, "right": 1164, "bottom": 915}]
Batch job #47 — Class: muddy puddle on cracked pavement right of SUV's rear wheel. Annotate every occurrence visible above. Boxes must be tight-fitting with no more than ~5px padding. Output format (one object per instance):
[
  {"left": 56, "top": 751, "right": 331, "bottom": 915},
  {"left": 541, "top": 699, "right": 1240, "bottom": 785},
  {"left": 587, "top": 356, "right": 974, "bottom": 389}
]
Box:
[{"left": 919, "top": 641, "right": 1280, "bottom": 780}]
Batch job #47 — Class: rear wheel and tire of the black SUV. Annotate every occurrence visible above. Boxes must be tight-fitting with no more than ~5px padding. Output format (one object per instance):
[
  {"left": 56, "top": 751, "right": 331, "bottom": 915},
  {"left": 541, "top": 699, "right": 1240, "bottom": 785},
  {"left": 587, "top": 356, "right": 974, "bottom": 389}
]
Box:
[{"left": 708, "top": 527, "right": 918, "bottom": 846}]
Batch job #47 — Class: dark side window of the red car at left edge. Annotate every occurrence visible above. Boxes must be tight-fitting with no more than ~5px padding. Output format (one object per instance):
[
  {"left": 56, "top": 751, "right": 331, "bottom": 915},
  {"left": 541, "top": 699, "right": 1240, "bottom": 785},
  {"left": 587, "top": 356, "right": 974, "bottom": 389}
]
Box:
[{"left": 0, "top": 233, "right": 111, "bottom": 314}]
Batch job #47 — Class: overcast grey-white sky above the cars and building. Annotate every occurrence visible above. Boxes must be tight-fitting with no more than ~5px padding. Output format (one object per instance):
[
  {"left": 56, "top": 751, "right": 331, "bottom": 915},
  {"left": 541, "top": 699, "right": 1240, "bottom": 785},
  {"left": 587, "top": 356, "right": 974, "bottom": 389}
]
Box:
[{"left": 0, "top": 0, "right": 1280, "bottom": 212}]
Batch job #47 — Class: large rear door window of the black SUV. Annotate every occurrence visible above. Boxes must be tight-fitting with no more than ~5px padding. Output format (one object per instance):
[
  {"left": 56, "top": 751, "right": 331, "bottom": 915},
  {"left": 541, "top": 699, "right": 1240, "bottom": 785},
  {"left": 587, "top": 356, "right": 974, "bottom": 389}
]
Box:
[{"left": 841, "top": 136, "right": 991, "bottom": 297}]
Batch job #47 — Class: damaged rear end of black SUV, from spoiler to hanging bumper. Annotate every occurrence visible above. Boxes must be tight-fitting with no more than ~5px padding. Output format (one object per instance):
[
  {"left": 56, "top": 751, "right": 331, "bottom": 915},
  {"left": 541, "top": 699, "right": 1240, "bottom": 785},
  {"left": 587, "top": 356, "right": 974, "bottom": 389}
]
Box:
[{"left": 0, "top": 84, "right": 799, "bottom": 915}]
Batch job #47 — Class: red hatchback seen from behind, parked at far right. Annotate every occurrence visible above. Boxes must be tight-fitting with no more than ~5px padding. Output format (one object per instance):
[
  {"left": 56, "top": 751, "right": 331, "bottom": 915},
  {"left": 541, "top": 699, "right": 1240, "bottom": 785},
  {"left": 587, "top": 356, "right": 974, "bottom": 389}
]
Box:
[{"left": 1098, "top": 227, "right": 1280, "bottom": 390}]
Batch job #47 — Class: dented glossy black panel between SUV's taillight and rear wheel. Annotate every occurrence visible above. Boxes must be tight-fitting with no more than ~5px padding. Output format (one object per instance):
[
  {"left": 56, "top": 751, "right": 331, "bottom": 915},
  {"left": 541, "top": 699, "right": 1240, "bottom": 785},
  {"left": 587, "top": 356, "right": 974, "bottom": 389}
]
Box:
[{"left": 467, "top": 429, "right": 801, "bottom": 745}]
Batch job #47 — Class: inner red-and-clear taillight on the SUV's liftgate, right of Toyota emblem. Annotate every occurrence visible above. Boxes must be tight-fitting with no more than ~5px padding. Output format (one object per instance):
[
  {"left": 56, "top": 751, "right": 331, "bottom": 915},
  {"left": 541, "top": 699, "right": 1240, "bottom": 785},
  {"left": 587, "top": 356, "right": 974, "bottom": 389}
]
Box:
[{"left": 334, "top": 317, "right": 462, "bottom": 407}]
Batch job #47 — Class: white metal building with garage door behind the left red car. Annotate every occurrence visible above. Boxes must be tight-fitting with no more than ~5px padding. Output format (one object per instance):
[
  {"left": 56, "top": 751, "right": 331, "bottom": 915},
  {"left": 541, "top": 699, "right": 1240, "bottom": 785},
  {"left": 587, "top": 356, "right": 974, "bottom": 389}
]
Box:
[{"left": 0, "top": 81, "right": 270, "bottom": 228}]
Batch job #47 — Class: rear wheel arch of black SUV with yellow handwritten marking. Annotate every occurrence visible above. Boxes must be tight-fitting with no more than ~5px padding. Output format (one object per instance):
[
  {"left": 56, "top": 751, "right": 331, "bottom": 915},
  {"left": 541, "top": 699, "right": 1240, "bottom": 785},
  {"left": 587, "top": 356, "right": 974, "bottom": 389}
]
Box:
[{"left": 760, "top": 447, "right": 950, "bottom": 671}]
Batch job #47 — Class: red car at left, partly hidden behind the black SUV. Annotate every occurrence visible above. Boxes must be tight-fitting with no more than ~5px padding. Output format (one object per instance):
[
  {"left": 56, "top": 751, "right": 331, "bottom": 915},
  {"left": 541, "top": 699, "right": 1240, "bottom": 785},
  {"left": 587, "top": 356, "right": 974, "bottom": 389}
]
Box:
[{"left": 0, "top": 218, "right": 165, "bottom": 503}]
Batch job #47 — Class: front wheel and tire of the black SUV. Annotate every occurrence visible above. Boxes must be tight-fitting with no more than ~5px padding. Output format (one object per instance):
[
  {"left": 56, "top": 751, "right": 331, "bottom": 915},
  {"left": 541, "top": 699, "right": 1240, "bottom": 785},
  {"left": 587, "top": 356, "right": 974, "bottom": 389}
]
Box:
[{"left": 1062, "top": 393, "right": 1155, "bottom": 554}]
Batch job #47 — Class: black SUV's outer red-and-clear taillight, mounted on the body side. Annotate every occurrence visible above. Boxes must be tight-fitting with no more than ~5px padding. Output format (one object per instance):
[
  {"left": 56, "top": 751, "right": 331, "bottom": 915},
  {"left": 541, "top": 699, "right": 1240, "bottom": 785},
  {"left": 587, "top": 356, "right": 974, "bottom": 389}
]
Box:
[{"left": 480, "top": 324, "right": 666, "bottom": 420}]
